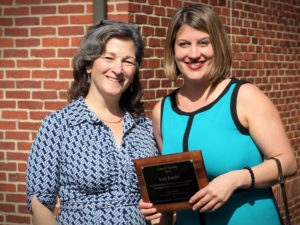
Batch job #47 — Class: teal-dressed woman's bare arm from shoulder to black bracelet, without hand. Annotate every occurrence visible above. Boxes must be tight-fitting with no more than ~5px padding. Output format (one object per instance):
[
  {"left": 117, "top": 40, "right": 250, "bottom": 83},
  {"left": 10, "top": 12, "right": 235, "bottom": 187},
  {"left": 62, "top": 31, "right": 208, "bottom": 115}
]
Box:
[{"left": 237, "top": 84, "right": 297, "bottom": 187}]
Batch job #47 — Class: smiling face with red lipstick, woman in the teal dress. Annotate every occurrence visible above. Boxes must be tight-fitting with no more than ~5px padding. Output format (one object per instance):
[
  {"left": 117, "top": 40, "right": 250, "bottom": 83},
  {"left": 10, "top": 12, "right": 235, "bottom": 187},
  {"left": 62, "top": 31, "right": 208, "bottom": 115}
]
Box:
[{"left": 174, "top": 24, "right": 214, "bottom": 80}]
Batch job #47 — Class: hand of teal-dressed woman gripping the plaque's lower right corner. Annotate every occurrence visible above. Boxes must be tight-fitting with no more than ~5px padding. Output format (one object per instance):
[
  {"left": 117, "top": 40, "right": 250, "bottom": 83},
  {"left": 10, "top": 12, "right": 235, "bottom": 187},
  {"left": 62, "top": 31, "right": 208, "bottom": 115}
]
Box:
[{"left": 189, "top": 171, "right": 238, "bottom": 212}]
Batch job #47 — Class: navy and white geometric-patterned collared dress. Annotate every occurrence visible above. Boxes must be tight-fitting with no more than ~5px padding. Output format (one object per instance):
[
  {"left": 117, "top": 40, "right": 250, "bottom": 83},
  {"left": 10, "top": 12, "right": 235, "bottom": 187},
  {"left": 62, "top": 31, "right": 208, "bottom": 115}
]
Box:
[{"left": 26, "top": 97, "right": 159, "bottom": 225}]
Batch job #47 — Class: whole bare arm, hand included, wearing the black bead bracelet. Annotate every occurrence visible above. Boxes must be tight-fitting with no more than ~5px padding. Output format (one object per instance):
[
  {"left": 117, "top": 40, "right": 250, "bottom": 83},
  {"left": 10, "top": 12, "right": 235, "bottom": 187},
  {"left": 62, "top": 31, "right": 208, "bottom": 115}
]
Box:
[{"left": 190, "top": 84, "right": 297, "bottom": 212}]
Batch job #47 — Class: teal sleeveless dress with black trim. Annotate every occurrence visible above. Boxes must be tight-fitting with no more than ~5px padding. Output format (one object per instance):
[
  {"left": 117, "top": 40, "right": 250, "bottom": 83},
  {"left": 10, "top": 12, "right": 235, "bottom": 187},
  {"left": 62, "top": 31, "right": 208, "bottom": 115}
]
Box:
[{"left": 161, "top": 79, "right": 281, "bottom": 225}]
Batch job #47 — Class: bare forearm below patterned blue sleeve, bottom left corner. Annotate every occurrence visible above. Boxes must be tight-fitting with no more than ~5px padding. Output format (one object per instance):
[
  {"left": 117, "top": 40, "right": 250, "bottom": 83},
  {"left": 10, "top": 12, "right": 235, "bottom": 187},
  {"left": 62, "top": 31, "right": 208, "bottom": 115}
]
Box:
[{"left": 31, "top": 195, "right": 57, "bottom": 225}]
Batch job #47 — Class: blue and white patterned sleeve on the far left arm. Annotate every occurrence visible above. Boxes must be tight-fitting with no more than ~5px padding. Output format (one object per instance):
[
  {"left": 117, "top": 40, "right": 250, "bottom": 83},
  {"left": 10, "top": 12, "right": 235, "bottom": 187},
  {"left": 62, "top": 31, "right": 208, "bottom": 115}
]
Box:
[{"left": 26, "top": 114, "right": 61, "bottom": 211}]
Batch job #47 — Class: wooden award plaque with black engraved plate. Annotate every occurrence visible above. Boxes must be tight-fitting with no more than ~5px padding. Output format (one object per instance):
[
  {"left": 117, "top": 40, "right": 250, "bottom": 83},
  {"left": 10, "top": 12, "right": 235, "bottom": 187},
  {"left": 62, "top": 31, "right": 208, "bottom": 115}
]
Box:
[{"left": 134, "top": 150, "right": 208, "bottom": 212}]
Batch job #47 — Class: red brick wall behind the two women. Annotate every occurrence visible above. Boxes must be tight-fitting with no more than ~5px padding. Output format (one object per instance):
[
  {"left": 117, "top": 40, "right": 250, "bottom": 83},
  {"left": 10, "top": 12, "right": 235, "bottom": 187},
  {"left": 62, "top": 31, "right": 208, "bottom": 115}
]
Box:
[{"left": 0, "top": 0, "right": 300, "bottom": 224}]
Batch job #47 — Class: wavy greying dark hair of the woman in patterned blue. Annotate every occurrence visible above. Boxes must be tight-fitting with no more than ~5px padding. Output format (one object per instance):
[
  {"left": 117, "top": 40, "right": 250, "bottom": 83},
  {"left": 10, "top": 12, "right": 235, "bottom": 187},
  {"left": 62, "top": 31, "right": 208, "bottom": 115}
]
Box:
[{"left": 68, "top": 20, "right": 144, "bottom": 118}]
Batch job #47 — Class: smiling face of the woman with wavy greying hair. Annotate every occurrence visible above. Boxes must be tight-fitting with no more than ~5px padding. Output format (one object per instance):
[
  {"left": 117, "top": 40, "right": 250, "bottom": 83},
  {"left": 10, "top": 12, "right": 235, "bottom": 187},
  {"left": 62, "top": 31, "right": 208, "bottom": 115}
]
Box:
[{"left": 87, "top": 38, "right": 136, "bottom": 98}]
